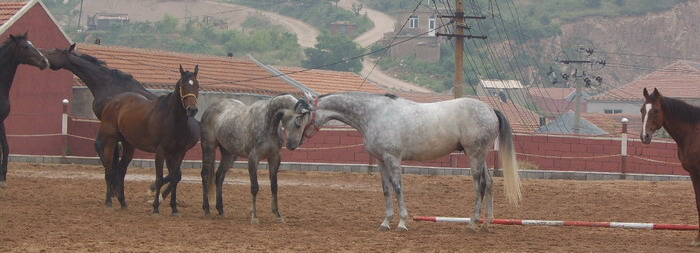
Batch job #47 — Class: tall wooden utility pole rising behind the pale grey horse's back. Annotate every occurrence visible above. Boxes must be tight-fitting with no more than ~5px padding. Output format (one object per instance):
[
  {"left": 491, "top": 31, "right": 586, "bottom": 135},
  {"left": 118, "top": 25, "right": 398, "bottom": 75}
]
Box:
[{"left": 435, "top": 0, "right": 487, "bottom": 98}]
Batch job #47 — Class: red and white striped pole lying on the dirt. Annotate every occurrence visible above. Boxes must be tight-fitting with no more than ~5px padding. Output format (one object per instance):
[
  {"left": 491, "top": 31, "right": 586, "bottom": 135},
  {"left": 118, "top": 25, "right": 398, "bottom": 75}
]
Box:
[{"left": 413, "top": 216, "right": 698, "bottom": 231}]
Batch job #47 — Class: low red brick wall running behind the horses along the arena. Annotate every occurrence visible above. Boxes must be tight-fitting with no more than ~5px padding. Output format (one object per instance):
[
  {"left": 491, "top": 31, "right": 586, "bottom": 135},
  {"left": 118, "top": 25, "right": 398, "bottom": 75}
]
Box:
[{"left": 56, "top": 119, "right": 687, "bottom": 175}]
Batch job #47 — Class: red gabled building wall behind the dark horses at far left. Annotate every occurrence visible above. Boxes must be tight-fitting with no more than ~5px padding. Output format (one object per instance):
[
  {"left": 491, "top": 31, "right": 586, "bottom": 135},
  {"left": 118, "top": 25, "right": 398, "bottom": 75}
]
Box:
[{"left": 0, "top": 0, "right": 73, "bottom": 155}]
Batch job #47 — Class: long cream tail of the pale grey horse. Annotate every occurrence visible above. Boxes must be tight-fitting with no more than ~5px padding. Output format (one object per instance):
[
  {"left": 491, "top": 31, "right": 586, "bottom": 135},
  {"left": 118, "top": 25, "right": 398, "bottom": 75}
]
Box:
[{"left": 494, "top": 110, "right": 522, "bottom": 205}]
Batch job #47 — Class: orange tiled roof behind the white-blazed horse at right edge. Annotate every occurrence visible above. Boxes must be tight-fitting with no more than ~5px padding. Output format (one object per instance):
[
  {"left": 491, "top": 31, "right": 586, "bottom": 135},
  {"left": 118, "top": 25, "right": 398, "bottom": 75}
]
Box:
[{"left": 588, "top": 60, "right": 700, "bottom": 101}]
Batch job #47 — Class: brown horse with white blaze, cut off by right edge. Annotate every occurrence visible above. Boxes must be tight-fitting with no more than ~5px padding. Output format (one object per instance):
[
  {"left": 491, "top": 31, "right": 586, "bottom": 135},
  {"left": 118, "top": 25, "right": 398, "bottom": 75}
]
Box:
[{"left": 640, "top": 88, "right": 700, "bottom": 246}]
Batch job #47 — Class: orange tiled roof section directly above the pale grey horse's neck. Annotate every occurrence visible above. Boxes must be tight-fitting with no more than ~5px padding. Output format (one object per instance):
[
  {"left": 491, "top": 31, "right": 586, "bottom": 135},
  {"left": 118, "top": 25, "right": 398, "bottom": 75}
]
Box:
[{"left": 275, "top": 66, "right": 388, "bottom": 95}]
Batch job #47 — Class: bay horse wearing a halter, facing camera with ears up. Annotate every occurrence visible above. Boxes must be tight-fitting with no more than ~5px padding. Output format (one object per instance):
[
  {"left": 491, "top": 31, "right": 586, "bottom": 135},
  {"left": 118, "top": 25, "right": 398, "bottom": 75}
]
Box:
[{"left": 98, "top": 65, "right": 200, "bottom": 216}]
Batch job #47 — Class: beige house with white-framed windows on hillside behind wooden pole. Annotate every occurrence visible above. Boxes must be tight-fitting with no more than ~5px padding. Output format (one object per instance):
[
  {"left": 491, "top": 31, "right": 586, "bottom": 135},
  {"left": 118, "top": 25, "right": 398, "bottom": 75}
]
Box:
[{"left": 382, "top": 8, "right": 447, "bottom": 62}]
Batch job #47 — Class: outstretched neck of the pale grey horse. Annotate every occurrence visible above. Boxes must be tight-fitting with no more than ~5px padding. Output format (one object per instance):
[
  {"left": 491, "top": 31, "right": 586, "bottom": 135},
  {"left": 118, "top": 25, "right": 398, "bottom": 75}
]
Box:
[{"left": 315, "top": 93, "right": 374, "bottom": 132}]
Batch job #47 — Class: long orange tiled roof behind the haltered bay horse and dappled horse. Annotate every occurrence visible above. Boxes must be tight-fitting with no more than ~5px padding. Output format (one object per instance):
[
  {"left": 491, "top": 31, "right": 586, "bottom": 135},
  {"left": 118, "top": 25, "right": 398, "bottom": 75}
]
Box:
[{"left": 78, "top": 43, "right": 300, "bottom": 95}]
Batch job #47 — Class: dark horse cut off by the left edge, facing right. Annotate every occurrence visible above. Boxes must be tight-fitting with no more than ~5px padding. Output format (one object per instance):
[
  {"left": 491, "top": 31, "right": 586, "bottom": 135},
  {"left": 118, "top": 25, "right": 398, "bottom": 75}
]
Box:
[{"left": 0, "top": 33, "right": 49, "bottom": 188}]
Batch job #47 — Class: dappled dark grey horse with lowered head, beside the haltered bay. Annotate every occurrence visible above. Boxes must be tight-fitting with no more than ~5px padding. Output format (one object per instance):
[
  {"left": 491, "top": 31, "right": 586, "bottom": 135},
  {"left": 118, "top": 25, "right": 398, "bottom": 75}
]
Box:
[{"left": 202, "top": 94, "right": 311, "bottom": 224}]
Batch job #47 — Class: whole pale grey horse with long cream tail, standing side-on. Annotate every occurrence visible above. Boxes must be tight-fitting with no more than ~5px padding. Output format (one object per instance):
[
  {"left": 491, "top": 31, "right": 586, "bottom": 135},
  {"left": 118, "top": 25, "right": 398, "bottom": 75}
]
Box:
[{"left": 304, "top": 92, "right": 522, "bottom": 231}]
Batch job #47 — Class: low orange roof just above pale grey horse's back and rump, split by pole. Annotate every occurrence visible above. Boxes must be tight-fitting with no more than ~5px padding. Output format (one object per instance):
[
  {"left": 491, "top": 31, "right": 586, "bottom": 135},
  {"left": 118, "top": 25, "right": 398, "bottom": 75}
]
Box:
[{"left": 394, "top": 92, "right": 540, "bottom": 133}]
